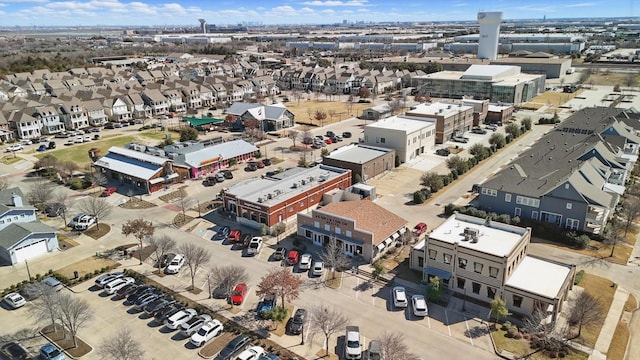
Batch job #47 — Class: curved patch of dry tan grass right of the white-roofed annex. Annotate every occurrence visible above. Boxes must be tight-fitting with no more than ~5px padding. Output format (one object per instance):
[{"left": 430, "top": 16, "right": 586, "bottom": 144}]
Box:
[{"left": 575, "top": 273, "right": 616, "bottom": 348}]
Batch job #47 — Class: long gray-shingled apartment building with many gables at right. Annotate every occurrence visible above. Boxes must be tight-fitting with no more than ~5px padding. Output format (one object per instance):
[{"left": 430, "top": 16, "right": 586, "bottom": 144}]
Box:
[{"left": 476, "top": 108, "right": 640, "bottom": 234}]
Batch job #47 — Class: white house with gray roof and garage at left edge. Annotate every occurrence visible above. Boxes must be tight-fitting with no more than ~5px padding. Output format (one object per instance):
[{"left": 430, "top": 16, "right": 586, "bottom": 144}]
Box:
[{"left": 0, "top": 187, "right": 58, "bottom": 265}]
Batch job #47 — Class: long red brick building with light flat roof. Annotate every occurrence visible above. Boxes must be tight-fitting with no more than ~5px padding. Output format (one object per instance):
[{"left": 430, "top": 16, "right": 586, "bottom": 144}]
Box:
[{"left": 223, "top": 165, "right": 351, "bottom": 229}]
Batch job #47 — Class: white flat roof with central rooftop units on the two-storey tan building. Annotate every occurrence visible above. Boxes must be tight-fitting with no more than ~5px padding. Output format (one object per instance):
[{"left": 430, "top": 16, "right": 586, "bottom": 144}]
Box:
[{"left": 429, "top": 214, "right": 527, "bottom": 257}]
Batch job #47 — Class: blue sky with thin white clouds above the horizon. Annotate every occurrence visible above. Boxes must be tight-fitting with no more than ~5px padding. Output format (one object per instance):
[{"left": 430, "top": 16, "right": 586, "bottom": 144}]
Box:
[{"left": 0, "top": 0, "right": 640, "bottom": 27}]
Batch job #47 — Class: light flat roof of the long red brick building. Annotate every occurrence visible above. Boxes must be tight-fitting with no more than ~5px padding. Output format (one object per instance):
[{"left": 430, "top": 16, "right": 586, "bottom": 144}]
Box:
[{"left": 226, "top": 164, "right": 349, "bottom": 206}]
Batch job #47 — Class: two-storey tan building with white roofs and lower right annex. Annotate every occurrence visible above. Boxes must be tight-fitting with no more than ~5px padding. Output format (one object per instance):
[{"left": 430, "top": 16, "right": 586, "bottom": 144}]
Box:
[{"left": 410, "top": 213, "right": 576, "bottom": 321}]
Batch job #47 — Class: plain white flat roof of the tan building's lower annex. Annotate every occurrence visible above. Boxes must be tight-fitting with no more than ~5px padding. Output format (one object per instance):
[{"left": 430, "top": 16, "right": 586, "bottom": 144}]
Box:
[{"left": 505, "top": 256, "right": 571, "bottom": 299}]
